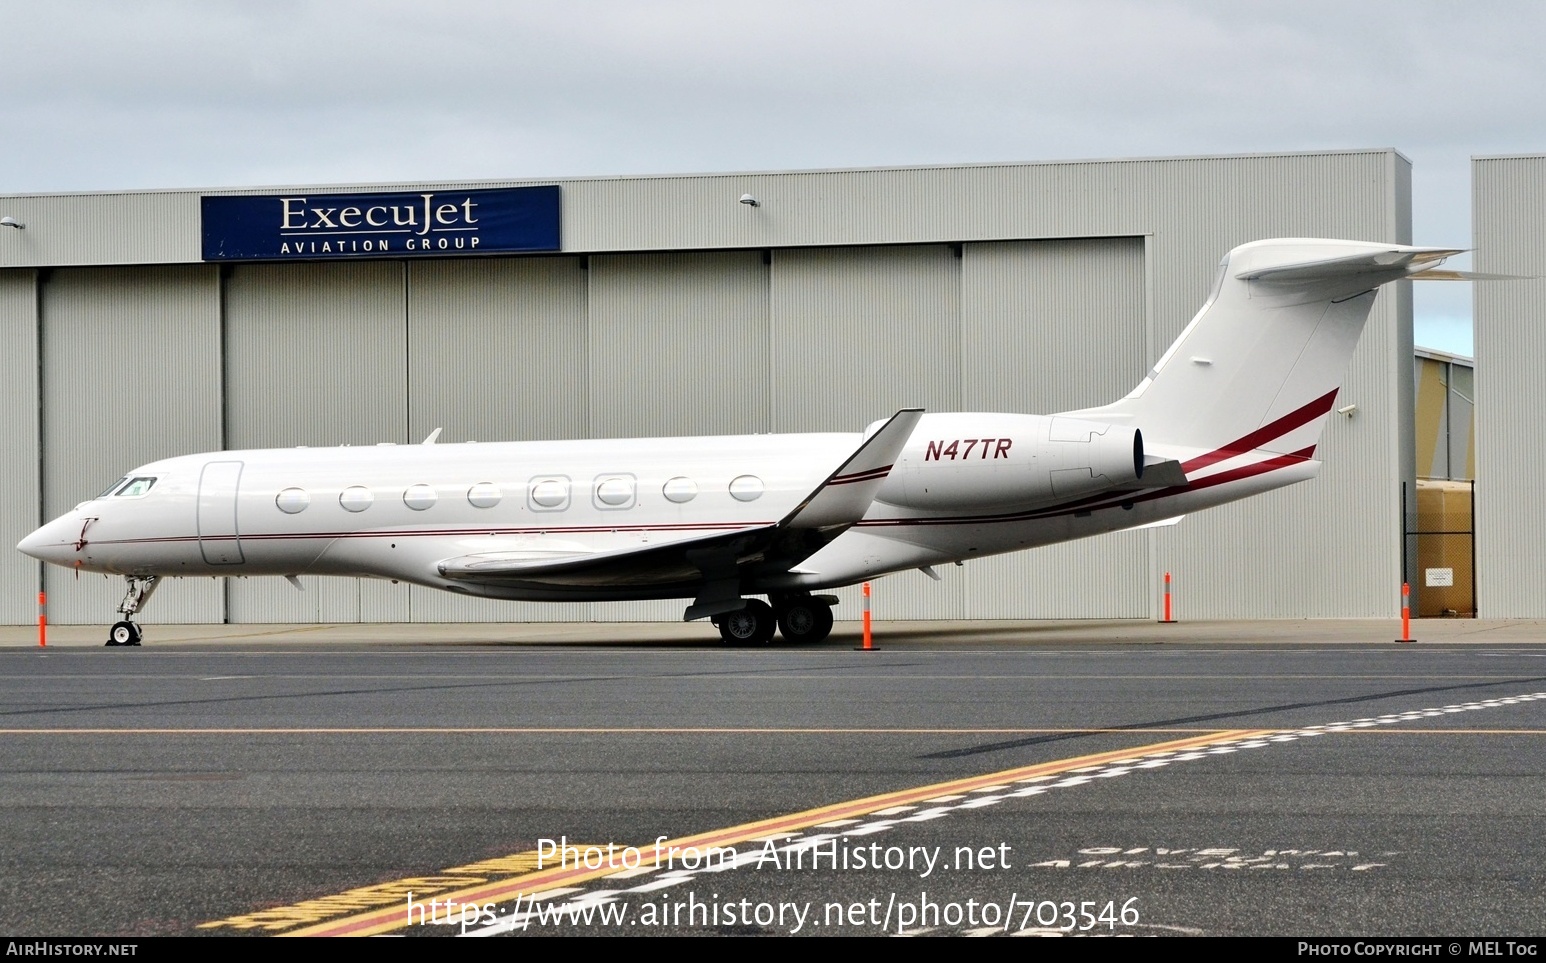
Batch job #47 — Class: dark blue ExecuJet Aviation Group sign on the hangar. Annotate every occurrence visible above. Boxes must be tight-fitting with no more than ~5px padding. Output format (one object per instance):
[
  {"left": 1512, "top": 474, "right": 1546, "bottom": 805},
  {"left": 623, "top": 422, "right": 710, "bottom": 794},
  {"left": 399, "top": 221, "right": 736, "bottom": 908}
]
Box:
[{"left": 201, "top": 185, "right": 558, "bottom": 261}]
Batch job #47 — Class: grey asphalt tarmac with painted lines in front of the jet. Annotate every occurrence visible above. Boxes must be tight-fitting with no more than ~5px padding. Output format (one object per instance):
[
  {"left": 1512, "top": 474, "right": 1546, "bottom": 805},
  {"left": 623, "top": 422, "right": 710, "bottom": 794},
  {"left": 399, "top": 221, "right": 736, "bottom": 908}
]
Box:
[{"left": 0, "top": 621, "right": 1546, "bottom": 937}]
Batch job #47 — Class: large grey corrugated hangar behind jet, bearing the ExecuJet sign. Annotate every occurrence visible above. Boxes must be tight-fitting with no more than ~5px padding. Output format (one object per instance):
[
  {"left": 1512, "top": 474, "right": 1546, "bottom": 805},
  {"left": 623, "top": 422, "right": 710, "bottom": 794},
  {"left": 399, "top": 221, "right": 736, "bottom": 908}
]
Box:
[{"left": 0, "top": 150, "right": 1422, "bottom": 623}]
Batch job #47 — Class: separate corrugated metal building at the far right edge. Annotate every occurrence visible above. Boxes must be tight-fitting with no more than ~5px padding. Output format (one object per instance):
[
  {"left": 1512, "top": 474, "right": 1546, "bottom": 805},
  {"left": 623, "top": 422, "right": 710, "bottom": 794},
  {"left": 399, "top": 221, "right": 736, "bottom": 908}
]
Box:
[{"left": 1472, "top": 156, "right": 1546, "bottom": 618}]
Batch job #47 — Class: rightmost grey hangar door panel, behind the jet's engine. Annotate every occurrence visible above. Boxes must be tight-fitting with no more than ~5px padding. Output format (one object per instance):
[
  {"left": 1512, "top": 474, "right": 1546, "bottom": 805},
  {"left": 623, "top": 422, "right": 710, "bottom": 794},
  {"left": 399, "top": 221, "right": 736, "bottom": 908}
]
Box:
[{"left": 962, "top": 238, "right": 1163, "bottom": 618}]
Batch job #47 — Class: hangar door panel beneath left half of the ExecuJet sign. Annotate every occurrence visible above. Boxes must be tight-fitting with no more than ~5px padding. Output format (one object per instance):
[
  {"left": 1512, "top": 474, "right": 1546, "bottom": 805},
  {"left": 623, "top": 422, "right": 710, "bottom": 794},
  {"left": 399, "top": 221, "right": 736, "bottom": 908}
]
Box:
[{"left": 224, "top": 261, "right": 408, "bottom": 621}]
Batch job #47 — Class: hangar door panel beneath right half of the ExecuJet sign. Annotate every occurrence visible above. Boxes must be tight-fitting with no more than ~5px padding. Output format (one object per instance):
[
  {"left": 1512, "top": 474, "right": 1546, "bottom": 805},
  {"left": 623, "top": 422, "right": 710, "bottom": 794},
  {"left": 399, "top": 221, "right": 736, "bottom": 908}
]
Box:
[{"left": 408, "top": 251, "right": 589, "bottom": 621}]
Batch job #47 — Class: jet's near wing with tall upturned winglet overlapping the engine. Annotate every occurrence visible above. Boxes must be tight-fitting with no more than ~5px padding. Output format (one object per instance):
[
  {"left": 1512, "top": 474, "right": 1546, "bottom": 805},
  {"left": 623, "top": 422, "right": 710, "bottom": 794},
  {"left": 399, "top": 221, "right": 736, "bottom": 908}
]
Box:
[{"left": 438, "top": 408, "right": 923, "bottom": 618}]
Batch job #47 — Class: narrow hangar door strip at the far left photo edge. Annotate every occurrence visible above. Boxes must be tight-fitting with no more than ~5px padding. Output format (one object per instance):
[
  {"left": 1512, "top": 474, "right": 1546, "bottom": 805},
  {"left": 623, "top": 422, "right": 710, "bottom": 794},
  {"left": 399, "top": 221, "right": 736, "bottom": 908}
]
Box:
[{"left": 0, "top": 271, "right": 38, "bottom": 624}]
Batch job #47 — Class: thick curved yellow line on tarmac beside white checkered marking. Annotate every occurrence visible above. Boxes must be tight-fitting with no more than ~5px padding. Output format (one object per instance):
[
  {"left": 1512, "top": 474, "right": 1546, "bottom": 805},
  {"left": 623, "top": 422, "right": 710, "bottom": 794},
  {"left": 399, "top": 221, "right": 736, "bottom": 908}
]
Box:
[{"left": 259, "top": 730, "right": 1283, "bottom": 937}]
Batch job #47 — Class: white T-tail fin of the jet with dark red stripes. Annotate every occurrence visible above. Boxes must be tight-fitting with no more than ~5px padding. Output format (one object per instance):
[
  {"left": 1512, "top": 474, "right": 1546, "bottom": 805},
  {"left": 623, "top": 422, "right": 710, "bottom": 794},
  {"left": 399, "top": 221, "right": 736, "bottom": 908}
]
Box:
[{"left": 1071, "top": 238, "right": 1461, "bottom": 454}]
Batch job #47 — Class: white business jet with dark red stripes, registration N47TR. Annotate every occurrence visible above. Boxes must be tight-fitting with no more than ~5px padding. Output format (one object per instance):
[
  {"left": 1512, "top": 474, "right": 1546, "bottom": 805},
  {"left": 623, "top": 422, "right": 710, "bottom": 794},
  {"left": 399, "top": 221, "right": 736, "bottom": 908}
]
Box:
[{"left": 19, "top": 238, "right": 1459, "bottom": 645}]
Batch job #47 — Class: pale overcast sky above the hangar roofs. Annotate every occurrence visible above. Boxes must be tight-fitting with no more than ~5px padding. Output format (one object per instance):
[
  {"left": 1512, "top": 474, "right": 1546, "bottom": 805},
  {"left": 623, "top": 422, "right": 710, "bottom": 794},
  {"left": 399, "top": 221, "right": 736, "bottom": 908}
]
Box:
[{"left": 0, "top": 0, "right": 1546, "bottom": 354}]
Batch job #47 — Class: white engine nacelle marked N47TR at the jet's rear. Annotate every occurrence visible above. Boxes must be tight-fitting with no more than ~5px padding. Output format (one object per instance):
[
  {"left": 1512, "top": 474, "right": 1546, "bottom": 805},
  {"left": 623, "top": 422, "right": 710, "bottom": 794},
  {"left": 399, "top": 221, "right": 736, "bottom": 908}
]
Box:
[{"left": 877, "top": 411, "right": 1144, "bottom": 512}]
